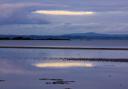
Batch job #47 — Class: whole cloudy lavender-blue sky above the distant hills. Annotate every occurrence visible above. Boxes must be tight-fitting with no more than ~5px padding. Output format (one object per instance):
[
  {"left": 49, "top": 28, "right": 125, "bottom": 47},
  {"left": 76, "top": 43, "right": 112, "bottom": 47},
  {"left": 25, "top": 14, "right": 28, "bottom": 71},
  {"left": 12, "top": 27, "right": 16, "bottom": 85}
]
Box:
[{"left": 0, "top": 0, "right": 128, "bottom": 35}]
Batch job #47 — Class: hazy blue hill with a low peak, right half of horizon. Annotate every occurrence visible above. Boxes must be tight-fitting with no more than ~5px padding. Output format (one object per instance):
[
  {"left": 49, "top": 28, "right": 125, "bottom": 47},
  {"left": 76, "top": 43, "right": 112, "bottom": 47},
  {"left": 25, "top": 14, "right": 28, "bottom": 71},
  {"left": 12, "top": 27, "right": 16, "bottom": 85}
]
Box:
[{"left": 62, "top": 32, "right": 128, "bottom": 40}]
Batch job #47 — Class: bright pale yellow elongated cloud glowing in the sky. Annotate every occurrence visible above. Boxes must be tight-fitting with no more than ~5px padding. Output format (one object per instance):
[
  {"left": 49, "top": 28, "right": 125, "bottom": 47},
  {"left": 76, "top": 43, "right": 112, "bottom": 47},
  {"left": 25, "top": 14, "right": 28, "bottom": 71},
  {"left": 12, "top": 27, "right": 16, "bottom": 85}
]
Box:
[{"left": 33, "top": 10, "right": 95, "bottom": 16}]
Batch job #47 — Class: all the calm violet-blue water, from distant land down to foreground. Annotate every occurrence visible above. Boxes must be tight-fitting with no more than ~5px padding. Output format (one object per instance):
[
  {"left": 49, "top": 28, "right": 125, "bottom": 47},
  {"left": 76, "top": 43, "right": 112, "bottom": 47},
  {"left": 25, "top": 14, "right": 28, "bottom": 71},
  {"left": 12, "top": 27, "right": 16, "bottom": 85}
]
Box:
[{"left": 0, "top": 41, "right": 128, "bottom": 89}]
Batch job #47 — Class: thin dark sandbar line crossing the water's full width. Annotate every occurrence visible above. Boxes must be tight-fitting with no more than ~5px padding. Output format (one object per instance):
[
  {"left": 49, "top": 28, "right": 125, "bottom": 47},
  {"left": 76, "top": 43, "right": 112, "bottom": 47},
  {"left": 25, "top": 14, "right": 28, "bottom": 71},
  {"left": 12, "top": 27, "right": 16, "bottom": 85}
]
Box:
[{"left": 0, "top": 46, "right": 128, "bottom": 51}]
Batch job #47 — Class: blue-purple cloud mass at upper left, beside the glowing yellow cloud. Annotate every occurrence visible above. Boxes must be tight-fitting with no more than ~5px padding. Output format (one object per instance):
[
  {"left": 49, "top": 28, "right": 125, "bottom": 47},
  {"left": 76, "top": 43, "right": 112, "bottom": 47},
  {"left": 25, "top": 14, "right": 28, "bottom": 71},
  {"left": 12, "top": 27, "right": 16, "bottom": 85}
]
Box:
[{"left": 0, "top": 3, "right": 67, "bottom": 25}]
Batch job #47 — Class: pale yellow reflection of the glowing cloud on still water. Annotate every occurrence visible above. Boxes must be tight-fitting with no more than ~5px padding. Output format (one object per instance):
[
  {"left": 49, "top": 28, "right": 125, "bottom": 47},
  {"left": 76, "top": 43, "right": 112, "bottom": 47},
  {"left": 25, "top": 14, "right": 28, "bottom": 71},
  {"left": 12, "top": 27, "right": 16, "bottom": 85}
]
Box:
[{"left": 34, "top": 62, "right": 94, "bottom": 68}]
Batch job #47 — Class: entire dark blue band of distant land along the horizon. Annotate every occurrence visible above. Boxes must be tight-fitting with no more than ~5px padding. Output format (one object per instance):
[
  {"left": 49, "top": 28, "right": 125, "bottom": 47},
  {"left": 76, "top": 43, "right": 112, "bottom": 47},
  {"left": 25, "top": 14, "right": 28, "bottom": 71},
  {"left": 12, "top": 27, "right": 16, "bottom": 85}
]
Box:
[{"left": 0, "top": 32, "right": 128, "bottom": 40}]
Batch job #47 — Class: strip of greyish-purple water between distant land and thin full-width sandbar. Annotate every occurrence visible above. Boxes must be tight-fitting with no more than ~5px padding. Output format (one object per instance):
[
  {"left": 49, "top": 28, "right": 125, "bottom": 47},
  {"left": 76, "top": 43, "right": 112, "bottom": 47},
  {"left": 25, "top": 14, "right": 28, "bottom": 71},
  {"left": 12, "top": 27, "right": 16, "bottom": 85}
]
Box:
[{"left": 0, "top": 40, "right": 128, "bottom": 48}]
